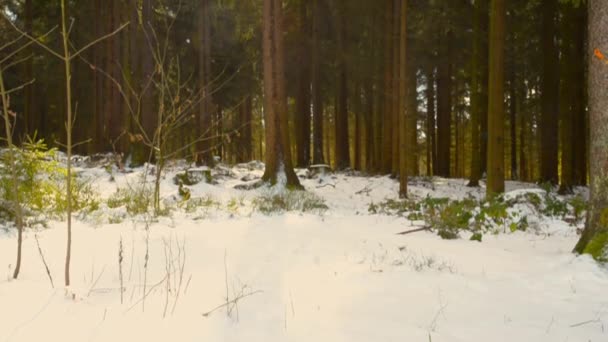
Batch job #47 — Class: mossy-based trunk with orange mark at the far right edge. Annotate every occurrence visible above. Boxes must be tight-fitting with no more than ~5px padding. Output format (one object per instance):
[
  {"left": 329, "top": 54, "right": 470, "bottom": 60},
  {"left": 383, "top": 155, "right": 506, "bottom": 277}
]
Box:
[{"left": 574, "top": 0, "right": 608, "bottom": 261}]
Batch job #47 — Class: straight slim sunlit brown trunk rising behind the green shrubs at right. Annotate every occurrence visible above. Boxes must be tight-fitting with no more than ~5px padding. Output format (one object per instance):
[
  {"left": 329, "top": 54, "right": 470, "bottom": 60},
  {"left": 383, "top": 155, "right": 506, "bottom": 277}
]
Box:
[{"left": 487, "top": 0, "right": 505, "bottom": 196}]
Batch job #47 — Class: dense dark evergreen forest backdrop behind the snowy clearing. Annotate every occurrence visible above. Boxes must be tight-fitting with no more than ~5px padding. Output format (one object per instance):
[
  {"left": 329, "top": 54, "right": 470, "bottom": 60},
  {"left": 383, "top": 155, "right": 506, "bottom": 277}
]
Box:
[{"left": 0, "top": 0, "right": 588, "bottom": 191}]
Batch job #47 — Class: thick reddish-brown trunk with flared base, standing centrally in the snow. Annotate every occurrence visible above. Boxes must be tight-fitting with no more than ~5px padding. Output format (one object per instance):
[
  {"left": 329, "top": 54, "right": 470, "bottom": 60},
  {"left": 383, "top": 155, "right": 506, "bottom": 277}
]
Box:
[{"left": 262, "top": 0, "right": 301, "bottom": 188}]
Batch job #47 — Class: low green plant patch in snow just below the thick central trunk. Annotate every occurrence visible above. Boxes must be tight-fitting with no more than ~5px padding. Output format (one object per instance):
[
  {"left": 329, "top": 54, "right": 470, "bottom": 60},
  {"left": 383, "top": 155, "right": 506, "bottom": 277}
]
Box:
[{"left": 253, "top": 190, "right": 329, "bottom": 215}]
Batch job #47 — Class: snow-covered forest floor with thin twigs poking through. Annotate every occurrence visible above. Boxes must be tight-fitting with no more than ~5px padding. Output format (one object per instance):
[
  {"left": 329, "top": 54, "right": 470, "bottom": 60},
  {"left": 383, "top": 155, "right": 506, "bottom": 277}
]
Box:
[{"left": 0, "top": 159, "right": 608, "bottom": 342}]
